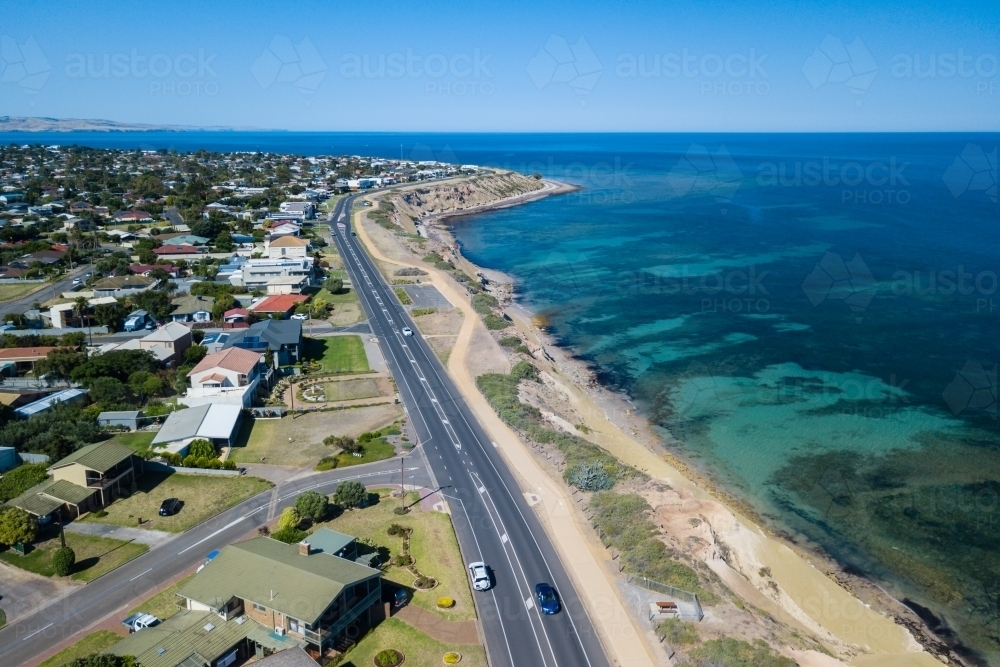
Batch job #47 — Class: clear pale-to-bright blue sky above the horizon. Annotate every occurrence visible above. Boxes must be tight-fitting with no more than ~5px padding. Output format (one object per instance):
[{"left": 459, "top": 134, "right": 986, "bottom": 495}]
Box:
[{"left": 0, "top": 0, "right": 1000, "bottom": 131}]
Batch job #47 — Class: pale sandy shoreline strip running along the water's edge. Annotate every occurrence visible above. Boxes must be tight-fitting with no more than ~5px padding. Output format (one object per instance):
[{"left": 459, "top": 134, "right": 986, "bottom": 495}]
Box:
[{"left": 424, "top": 181, "right": 956, "bottom": 665}]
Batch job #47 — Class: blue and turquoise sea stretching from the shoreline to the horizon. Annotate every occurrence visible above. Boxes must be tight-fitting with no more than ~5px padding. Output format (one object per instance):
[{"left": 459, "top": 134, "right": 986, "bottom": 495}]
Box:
[{"left": 9, "top": 132, "right": 1000, "bottom": 664}]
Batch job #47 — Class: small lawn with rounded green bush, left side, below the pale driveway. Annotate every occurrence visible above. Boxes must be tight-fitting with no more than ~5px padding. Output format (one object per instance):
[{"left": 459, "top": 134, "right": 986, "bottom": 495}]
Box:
[{"left": 0, "top": 533, "right": 149, "bottom": 581}]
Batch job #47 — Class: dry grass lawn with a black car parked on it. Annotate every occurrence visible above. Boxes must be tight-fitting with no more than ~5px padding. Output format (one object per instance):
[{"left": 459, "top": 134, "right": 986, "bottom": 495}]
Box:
[{"left": 83, "top": 472, "right": 273, "bottom": 533}]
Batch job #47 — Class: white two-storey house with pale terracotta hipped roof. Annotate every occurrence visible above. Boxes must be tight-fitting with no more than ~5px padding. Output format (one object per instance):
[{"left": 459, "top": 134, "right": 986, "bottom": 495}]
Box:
[{"left": 177, "top": 347, "right": 272, "bottom": 408}]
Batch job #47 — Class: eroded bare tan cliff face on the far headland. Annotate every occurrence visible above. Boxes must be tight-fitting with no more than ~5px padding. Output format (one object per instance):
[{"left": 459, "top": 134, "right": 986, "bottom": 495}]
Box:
[{"left": 389, "top": 172, "right": 545, "bottom": 218}]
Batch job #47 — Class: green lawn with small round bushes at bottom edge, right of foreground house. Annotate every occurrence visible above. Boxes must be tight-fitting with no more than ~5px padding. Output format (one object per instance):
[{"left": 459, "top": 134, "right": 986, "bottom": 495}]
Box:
[{"left": 340, "top": 618, "right": 486, "bottom": 667}]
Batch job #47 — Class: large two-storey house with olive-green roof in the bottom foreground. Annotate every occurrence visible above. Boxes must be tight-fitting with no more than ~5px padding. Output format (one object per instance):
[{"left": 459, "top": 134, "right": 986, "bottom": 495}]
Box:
[{"left": 174, "top": 537, "right": 383, "bottom": 667}]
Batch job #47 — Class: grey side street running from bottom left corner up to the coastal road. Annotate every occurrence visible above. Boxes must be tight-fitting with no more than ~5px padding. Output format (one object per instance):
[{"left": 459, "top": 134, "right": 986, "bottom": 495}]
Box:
[{"left": 0, "top": 460, "right": 431, "bottom": 667}]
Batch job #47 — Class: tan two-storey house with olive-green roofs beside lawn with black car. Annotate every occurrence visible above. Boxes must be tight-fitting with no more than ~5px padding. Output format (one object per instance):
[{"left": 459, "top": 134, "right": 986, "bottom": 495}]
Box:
[{"left": 7, "top": 440, "right": 142, "bottom": 521}]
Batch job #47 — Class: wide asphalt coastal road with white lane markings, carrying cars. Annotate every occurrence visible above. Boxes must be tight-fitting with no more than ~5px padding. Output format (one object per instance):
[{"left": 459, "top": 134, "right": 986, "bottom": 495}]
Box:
[{"left": 330, "top": 197, "right": 609, "bottom": 667}]
